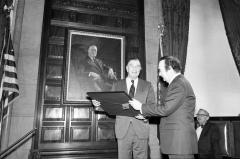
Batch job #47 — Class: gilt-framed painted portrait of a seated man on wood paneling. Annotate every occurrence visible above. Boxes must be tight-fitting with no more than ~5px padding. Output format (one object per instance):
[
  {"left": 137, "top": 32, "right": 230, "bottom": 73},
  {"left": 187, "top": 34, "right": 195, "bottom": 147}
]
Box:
[{"left": 64, "top": 30, "right": 125, "bottom": 102}]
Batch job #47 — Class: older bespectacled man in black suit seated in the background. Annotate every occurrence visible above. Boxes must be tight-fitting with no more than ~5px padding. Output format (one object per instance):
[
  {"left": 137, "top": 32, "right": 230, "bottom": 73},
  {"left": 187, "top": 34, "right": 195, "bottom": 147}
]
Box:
[{"left": 196, "top": 109, "right": 220, "bottom": 159}]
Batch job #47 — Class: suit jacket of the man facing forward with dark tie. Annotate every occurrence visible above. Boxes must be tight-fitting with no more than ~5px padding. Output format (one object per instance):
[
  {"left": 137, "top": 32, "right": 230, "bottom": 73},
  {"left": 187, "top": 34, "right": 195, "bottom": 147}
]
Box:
[{"left": 112, "top": 79, "right": 155, "bottom": 139}]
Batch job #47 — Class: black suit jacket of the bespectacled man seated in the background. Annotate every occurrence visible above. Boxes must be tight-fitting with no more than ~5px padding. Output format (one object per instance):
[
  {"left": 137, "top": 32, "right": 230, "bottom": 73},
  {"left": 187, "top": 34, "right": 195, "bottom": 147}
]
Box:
[{"left": 198, "top": 122, "right": 220, "bottom": 159}]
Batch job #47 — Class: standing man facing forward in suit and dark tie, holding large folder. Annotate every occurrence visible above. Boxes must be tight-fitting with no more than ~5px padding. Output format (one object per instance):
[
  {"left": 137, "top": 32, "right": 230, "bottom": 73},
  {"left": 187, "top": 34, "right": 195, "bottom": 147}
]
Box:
[{"left": 92, "top": 59, "right": 155, "bottom": 159}]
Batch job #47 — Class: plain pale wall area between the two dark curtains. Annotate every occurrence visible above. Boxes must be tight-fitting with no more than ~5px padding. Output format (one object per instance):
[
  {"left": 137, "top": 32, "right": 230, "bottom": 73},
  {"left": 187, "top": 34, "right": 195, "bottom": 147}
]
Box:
[{"left": 185, "top": 0, "right": 240, "bottom": 116}]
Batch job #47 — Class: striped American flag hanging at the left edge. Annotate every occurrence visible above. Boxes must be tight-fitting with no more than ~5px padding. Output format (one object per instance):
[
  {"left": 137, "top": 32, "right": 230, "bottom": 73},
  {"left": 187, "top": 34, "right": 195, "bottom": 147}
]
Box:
[{"left": 0, "top": 35, "right": 19, "bottom": 117}]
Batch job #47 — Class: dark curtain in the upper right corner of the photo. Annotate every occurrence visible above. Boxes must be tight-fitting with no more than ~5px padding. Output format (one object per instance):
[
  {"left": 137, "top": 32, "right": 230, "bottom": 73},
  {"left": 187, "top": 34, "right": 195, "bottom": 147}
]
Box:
[{"left": 219, "top": 0, "right": 240, "bottom": 74}]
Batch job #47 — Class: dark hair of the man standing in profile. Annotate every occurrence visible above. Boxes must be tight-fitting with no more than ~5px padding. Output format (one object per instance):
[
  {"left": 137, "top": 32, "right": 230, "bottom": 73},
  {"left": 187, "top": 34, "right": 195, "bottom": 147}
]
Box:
[{"left": 159, "top": 56, "right": 182, "bottom": 72}]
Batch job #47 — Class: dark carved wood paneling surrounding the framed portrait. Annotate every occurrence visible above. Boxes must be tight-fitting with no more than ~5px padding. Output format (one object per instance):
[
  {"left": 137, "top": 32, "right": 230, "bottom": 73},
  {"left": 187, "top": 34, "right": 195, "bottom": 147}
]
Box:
[{"left": 31, "top": 0, "right": 145, "bottom": 159}]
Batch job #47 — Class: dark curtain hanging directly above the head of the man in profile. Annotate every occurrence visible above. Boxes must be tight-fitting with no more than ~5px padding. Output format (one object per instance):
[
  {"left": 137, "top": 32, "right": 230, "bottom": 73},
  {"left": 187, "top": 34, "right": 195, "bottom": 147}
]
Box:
[{"left": 162, "top": 0, "right": 190, "bottom": 73}]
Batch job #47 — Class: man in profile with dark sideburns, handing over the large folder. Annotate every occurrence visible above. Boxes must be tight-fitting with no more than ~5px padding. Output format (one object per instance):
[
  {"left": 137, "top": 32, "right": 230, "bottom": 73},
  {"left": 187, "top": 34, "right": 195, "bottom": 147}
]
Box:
[{"left": 129, "top": 56, "right": 198, "bottom": 159}]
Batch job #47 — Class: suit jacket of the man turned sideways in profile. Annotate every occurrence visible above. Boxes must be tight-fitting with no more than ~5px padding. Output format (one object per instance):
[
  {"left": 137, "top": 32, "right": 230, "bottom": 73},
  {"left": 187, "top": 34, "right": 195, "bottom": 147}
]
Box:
[{"left": 142, "top": 75, "right": 198, "bottom": 155}]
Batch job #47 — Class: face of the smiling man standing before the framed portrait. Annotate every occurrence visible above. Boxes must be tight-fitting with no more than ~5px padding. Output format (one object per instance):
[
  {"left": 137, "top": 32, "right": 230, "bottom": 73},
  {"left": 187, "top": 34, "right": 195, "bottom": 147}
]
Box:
[{"left": 126, "top": 60, "right": 141, "bottom": 79}]
